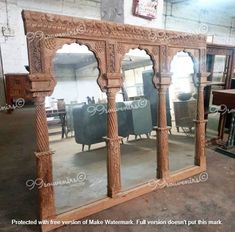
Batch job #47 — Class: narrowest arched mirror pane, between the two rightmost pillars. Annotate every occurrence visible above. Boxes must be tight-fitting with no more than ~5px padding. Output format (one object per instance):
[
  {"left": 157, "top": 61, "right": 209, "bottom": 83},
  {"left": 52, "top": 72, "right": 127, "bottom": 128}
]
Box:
[{"left": 167, "top": 51, "right": 197, "bottom": 171}]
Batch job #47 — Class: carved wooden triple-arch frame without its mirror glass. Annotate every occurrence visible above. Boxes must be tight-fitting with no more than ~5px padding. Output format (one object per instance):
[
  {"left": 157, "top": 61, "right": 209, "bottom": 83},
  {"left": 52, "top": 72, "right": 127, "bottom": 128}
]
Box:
[{"left": 22, "top": 11, "right": 208, "bottom": 231}]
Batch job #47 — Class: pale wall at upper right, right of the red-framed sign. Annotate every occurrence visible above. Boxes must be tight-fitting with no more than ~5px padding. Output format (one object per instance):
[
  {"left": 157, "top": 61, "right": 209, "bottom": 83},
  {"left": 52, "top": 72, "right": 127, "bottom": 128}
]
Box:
[{"left": 163, "top": 0, "right": 235, "bottom": 45}]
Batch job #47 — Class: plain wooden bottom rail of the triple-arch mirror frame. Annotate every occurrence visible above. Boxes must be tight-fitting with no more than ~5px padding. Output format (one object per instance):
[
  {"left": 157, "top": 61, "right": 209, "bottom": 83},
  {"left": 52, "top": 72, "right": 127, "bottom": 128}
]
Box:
[{"left": 41, "top": 166, "right": 205, "bottom": 232}]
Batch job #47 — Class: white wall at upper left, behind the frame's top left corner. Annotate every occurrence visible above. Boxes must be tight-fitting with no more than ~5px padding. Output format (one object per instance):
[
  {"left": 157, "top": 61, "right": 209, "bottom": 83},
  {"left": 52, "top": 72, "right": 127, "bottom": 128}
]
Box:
[{"left": 0, "top": 0, "right": 100, "bottom": 102}]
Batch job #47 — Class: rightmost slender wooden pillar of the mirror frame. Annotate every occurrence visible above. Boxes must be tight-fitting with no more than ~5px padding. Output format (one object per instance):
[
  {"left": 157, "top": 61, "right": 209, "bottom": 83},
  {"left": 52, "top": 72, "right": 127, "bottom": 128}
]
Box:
[{"left": 195, "top": 73, "right": 209, "bottom": 168}]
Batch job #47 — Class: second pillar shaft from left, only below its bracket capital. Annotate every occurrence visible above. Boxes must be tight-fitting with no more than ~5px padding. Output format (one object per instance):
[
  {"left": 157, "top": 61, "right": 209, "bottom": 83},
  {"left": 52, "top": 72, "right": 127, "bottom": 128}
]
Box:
[{"left": 107, "top": 88, "right": 121, "bottom": 197}]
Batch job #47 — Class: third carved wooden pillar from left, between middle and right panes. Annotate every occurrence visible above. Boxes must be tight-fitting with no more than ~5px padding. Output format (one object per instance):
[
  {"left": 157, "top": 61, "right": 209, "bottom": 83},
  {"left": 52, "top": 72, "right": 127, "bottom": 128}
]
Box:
[{"left": 156, "top": 73, "right": 170, "bottom": 179}]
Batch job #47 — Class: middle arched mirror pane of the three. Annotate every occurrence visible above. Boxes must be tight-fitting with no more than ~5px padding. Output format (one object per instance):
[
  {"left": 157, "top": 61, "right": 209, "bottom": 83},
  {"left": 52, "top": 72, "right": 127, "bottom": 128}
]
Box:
[{"left": 117, "top": 49, "right": 157, "bottom": 190}]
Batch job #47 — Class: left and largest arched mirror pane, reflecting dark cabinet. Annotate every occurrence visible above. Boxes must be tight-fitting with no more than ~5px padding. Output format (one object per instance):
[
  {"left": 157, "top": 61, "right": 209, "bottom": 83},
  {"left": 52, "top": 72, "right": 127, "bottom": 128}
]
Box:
[{"left": 46, "top": 43, "right": 107, "bottom": 213}]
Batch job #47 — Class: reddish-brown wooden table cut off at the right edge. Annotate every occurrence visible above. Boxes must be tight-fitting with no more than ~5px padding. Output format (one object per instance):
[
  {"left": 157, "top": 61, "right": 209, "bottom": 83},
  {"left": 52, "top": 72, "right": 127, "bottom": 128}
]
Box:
[{"left": 212, "top": 89, "right": 235, "bottom": 149}]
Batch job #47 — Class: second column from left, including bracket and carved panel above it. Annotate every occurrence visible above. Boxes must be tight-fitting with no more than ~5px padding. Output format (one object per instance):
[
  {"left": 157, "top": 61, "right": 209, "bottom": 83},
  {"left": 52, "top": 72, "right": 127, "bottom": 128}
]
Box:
[{"left": 103, "top": 40, "right": 122, "bottom": 197}]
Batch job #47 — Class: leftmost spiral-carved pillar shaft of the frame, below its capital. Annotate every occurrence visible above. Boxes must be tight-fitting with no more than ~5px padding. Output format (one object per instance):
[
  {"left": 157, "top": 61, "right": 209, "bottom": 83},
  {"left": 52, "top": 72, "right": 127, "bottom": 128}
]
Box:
[{"left": 34, "top": 97, "right": 55, "bottom": 219}]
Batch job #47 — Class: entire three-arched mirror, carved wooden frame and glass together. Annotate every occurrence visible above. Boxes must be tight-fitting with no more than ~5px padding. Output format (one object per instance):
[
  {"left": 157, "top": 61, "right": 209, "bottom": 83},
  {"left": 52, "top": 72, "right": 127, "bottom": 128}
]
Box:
[{"left": 23, "top": 11, "right": 208, "bottom": 231}]
